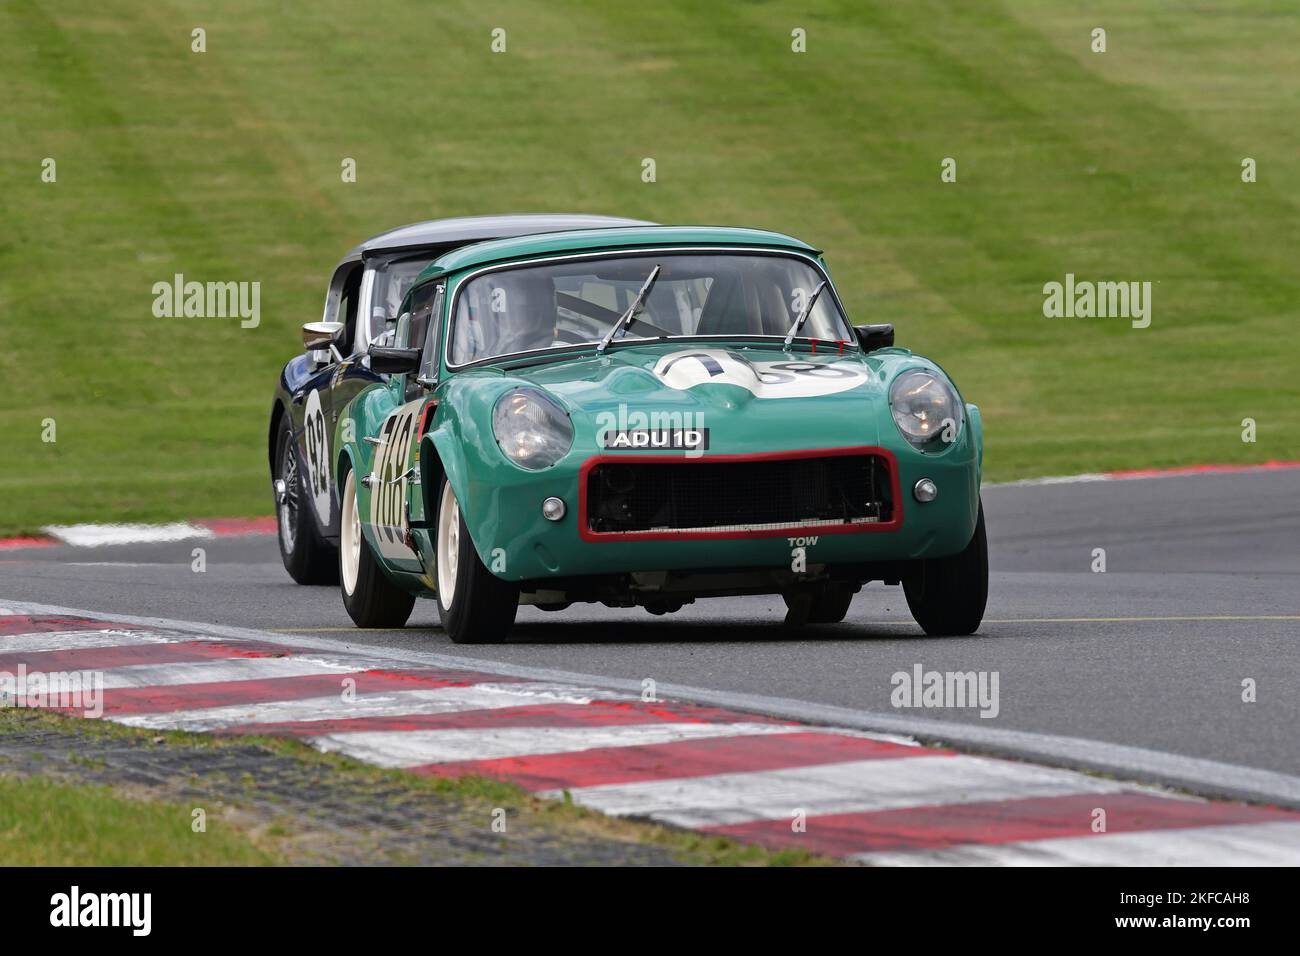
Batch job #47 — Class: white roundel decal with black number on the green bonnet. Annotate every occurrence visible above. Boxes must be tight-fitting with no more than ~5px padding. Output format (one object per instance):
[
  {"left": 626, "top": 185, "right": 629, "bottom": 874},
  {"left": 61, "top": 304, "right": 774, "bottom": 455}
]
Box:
[{"left": 654, "top": 349, "right": 867, "bottom": 398}]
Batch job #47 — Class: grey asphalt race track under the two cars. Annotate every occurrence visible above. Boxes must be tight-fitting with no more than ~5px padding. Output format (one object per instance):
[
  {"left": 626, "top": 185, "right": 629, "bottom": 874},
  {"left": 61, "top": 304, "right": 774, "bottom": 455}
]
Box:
[{"left": 0, "top": 470, "right": 1300, "bottom": 790}]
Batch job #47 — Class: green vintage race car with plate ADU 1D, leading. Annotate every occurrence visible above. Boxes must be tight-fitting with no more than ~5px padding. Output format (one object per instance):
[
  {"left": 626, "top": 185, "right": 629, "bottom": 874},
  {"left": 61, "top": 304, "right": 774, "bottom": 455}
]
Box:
[{"left": 330, "top": 225, "right": 988, "bottom": 643}]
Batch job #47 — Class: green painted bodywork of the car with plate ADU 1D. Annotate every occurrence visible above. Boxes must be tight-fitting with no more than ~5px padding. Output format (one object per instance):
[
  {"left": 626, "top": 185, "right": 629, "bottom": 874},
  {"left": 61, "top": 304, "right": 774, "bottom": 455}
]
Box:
[{"left": 334, "top": 226, "right": 983, "bottom": 594}]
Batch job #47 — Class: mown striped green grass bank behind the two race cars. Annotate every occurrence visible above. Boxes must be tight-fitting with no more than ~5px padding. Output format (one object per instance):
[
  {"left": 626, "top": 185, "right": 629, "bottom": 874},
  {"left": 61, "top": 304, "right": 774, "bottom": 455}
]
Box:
[{"left": 0, "top": 0, "right": 1300, "bottom": 533}]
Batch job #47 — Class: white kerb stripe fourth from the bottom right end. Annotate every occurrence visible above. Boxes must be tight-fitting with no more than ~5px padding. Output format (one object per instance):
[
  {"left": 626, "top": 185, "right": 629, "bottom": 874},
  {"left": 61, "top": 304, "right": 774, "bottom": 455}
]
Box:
[{"left": 109, "top": 684, "right": 611, "bottom": 732}]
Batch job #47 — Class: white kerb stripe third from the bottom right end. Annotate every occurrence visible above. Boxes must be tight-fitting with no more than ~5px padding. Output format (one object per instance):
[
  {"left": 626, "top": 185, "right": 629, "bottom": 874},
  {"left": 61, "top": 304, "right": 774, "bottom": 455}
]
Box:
[{"left": 312, "top": 723, "right": 818, "bottom": 767}]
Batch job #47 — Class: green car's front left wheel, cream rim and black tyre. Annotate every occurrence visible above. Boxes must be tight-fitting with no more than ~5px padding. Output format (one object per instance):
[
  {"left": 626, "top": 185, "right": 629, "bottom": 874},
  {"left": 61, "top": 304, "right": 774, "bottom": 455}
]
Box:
[{"left": 434, "top": 479, "right": 519, "bottom": 644}]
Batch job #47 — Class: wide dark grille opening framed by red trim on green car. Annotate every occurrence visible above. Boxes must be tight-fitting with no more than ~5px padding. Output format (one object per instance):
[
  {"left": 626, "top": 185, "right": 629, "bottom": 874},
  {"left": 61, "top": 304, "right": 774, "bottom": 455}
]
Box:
[{"left": 586, "top": 454, "right": 894, "bottom": 535}]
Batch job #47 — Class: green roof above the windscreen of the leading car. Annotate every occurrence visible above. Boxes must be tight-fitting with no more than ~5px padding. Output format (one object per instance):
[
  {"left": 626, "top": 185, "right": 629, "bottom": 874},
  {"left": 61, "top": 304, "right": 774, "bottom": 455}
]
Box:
[{"left": 417, "top": 224, "right": 820, "bottom": 281}]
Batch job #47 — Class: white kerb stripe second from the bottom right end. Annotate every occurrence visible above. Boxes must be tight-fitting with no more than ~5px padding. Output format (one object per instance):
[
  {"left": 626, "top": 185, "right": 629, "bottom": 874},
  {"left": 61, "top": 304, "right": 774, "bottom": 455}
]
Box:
[{"left": 542, "top": 756, "right": 1128, "bottom": 829}]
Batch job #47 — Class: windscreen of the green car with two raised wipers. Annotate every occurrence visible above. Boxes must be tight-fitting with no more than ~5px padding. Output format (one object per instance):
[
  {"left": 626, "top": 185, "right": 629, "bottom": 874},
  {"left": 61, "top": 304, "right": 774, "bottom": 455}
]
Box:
[{"left": 449, "top": 252, "right": 853, "bottom": 365}]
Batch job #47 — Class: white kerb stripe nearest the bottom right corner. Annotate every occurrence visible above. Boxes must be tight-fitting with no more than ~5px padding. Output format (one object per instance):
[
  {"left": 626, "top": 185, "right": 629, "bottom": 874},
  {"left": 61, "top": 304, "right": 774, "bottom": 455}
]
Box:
[{"left": 853, "top": 821, "right": 1300, "bottom": 866}]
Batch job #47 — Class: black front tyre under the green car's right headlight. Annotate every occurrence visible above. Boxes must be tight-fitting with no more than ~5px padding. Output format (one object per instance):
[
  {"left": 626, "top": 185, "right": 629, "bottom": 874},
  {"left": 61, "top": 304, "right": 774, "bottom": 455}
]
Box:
[{"left": 902, "top": 505, "right": 988, "bottom": 637}]
